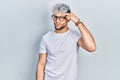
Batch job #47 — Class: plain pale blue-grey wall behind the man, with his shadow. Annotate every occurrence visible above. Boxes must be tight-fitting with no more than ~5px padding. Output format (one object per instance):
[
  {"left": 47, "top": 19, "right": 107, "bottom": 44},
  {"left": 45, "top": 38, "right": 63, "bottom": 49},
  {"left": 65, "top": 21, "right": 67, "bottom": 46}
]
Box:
[{"left": 0, "top": 0, "right": 120, "bottom": 80}]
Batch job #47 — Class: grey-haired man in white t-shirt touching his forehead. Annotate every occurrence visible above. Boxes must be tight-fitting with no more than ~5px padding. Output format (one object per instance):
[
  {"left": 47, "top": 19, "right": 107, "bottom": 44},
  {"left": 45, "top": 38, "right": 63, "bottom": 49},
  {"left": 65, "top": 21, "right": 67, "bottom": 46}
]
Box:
[{"left": 36, "top": 3, "right": 96, "bottom": 80}]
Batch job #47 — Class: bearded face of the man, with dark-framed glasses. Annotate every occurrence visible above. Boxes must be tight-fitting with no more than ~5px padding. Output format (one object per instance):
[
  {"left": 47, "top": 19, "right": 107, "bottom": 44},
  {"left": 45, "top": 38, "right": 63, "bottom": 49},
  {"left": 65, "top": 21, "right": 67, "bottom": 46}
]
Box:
[{"left": 52, "top": 12, "right": 68, "bottom": 30}]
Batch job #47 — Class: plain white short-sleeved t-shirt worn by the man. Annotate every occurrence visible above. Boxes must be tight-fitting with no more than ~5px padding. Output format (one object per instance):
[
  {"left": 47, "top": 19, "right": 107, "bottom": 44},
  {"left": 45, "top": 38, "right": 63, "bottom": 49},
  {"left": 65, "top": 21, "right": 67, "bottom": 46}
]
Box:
[{"left": 39, "top": 29, "right": 81, "bottom": 80}]
